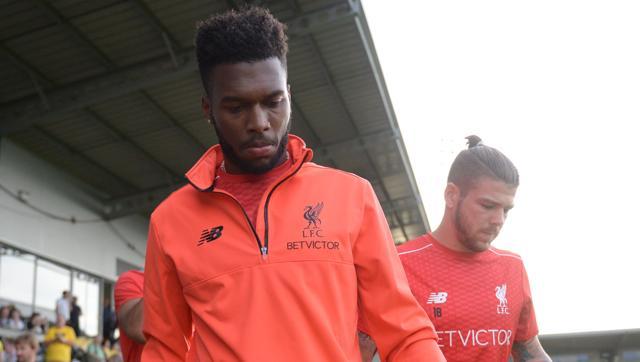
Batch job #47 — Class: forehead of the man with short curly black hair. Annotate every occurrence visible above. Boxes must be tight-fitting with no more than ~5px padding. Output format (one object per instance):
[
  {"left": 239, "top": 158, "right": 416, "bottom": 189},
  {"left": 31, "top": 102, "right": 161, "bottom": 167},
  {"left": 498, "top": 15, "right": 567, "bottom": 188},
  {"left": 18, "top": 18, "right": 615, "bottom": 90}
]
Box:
[{"left": 210, "top": 57, "right": 287, "bottom": 99}]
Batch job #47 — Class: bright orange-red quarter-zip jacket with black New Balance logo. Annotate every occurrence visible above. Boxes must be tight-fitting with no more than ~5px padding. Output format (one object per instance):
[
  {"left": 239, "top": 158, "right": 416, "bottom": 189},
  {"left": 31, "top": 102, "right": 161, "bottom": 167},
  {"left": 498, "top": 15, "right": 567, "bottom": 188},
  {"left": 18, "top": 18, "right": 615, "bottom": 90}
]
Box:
[{"left": 142, "top": 136, "right": 444, "bottom": 362}]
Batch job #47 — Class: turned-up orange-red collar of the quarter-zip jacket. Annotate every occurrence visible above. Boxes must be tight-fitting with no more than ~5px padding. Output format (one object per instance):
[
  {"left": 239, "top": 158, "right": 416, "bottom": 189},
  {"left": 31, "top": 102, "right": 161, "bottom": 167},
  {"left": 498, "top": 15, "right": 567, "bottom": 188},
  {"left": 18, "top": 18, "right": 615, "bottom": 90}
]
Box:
[{"left": 185, "top": 134, "right": 313, "bottom": 192}]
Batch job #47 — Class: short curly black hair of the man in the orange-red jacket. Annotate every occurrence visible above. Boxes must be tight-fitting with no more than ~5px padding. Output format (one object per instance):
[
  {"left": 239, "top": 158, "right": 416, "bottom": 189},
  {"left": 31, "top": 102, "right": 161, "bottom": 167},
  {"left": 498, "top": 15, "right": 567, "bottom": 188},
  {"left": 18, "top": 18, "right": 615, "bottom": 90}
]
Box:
[{"left": 195, "top": 6, "right": 288, "bottom": 93}]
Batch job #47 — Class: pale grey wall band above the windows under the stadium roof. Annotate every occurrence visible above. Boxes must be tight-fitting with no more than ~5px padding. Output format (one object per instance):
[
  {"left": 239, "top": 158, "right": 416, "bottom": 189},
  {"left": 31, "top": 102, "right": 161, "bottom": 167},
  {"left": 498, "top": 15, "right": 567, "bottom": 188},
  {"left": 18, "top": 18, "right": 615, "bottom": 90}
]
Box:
[{"left": 0, "top": 137, "right": 148, "bottom": 280}]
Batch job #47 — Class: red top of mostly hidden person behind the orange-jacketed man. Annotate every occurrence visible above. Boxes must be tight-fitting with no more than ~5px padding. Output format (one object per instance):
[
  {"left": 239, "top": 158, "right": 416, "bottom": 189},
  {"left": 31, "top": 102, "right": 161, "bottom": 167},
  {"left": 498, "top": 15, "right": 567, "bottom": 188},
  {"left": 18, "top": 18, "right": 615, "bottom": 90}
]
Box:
[{"left": 113, "top": 270, "right": 144, "bottom": 362}]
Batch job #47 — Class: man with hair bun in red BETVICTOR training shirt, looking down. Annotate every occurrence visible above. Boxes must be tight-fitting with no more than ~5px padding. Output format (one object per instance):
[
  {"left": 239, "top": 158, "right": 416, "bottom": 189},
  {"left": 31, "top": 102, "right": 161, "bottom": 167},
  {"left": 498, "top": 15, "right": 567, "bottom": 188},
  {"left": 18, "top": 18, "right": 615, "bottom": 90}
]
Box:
[{"left": 361, "top": 136, "right": 551, "bottom": 362}]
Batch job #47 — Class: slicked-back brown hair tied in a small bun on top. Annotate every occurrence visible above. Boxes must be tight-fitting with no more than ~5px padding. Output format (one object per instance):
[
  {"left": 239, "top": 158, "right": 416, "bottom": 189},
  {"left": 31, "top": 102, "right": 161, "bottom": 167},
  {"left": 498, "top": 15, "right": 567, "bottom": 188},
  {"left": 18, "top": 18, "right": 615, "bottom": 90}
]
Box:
[{"left": 447, "top": 135, "right": 520, "bottom": 195}]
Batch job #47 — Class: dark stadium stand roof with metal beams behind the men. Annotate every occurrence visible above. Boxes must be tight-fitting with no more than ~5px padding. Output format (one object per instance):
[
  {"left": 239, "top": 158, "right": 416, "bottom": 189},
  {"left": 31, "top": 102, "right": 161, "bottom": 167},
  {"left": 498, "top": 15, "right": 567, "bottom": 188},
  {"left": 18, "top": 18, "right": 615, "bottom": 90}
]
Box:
[{"left": 0, "top": 0, "right": 428, "bottom": 242}]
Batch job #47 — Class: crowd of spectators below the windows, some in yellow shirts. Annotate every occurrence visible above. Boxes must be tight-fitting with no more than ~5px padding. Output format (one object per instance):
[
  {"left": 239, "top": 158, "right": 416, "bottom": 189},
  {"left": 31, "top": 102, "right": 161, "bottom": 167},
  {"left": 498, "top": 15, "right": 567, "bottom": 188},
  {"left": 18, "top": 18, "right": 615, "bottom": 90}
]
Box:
[{"left": 0, "top": 291, "right": 122, "bottom": 362}]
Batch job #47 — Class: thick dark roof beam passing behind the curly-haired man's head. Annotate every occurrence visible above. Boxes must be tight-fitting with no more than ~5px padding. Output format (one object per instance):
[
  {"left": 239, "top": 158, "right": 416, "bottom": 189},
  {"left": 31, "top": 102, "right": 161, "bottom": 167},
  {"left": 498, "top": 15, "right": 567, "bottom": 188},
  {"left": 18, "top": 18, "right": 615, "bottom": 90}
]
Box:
[{"left": 0, "top": 3, "right": 352, "bottom": 135}]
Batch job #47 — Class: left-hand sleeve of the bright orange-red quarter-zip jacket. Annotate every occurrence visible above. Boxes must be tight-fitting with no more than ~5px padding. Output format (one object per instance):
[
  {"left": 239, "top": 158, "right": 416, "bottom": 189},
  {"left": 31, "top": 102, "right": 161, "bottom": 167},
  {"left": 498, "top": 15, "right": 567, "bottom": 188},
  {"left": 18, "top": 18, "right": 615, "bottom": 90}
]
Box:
[{"left": 141, "top": 215, "right": 191, "bottom": 362}]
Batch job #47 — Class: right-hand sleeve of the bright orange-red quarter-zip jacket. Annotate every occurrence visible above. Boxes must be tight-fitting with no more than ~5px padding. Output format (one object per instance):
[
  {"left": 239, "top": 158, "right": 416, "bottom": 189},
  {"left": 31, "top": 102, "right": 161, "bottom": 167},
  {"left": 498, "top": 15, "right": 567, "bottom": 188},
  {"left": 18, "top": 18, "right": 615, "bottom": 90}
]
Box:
[{"left": 353, "top": 182, "right": 445, "bottom": 361}]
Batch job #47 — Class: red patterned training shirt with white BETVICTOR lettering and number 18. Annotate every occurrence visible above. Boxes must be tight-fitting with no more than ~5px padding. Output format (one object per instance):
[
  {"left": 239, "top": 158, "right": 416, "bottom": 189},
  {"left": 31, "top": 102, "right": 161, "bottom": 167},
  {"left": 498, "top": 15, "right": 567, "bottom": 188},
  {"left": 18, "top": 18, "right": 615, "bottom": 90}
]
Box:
[{"left": 398, "top": 235, "right": 538, "bottom": 362}]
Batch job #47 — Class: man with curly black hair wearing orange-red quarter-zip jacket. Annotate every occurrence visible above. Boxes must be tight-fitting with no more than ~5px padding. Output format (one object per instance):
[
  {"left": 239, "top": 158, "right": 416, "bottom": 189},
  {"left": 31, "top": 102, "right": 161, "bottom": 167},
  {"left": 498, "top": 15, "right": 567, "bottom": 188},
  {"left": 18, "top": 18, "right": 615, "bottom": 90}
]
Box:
[{"left": 142, "top": 7, "right": 444, "bottom": 362}]
